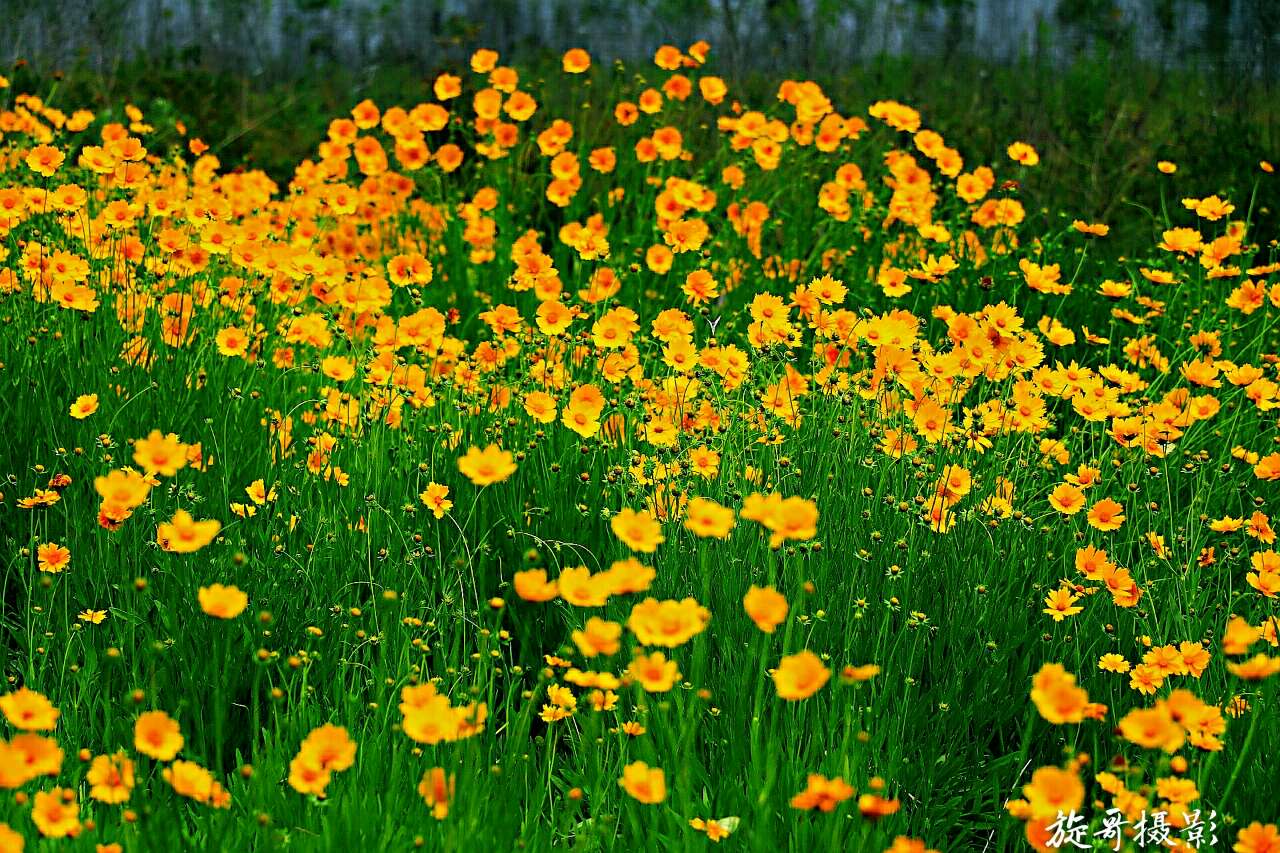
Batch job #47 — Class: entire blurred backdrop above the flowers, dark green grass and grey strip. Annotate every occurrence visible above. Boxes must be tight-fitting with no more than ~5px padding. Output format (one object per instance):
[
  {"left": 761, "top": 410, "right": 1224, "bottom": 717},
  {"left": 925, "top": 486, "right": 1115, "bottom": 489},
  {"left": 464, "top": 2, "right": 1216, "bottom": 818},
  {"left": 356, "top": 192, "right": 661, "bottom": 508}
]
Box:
[{"left": 0, "top": 0, "right": 1280, "bottom": 240}]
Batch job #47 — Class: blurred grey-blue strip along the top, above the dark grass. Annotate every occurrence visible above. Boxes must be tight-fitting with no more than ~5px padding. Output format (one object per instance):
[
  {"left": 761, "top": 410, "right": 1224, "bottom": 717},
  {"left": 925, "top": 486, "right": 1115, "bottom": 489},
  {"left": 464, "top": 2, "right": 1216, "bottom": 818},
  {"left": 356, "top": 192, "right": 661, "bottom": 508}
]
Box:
[{"left": 0, "top": 0, "right": 1280, "bottom": 77}]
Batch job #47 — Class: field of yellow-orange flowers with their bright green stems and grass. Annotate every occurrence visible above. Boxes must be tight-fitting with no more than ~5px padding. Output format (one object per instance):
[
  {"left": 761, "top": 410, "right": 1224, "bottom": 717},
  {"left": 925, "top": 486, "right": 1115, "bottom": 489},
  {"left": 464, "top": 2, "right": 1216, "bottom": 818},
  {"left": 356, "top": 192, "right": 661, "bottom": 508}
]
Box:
[{"left": 0, "top": 42, "right": 1280, "bottom": 853}]
